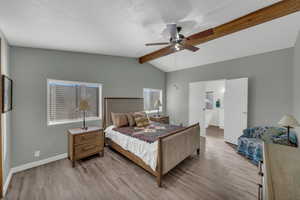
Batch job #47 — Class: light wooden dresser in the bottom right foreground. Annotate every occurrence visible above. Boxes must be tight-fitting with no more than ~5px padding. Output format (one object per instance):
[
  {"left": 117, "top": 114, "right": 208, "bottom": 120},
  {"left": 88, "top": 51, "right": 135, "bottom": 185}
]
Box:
[{"left": 258, "top": 144, "right": 300, "bottom": 200}]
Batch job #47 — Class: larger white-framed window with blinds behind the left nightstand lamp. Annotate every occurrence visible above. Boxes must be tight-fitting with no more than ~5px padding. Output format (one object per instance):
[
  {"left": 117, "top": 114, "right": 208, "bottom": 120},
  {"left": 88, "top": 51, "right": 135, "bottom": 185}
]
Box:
[{"left": 47, "top": 79, "right": 102, "bottom": 125}]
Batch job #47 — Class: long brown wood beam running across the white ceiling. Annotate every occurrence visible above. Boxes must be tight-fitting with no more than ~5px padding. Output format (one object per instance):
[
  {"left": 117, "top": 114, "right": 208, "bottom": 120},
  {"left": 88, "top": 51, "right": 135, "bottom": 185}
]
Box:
[{"left": 139, "top": 0, "right": 300, "bottom": 64}]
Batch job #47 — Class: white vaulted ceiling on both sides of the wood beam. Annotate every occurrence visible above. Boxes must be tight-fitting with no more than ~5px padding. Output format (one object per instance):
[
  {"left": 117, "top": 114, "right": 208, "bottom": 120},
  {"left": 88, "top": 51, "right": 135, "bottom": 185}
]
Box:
[{"left": 0, "top": 0, "right": 300, "bottom": 71}]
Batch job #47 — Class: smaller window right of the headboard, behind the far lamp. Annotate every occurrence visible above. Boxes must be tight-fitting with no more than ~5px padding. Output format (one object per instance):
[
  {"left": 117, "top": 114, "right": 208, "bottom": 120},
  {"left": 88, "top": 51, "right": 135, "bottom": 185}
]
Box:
[{"left": 143, "top": 88, "right": 162, "bottom": 113}]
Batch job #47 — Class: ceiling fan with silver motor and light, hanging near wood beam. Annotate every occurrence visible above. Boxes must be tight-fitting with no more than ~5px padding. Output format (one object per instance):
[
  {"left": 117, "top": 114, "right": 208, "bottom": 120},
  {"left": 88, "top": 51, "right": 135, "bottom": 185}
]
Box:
[{"left": 145, "top": 24, "right": 199, "bottom": 53}]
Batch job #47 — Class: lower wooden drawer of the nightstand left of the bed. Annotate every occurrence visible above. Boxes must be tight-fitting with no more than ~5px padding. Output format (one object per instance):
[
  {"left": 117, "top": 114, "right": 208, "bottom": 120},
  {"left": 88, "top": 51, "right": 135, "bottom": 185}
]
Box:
[{"left": 75, "top": 143, "right": 103, "bottom": 160}]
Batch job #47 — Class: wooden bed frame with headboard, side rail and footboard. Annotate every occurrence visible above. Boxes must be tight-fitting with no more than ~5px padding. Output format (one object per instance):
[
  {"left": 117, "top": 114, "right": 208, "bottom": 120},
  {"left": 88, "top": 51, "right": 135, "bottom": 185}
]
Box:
[{"left": 103, "top": 97, "right": 200, "bottom": 187}]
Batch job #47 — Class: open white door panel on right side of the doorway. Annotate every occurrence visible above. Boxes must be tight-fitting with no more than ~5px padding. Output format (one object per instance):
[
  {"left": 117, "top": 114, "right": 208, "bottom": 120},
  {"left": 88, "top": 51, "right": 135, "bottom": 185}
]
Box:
[{"left": 224, "top": 78, "right": 248, "bottom": 144}]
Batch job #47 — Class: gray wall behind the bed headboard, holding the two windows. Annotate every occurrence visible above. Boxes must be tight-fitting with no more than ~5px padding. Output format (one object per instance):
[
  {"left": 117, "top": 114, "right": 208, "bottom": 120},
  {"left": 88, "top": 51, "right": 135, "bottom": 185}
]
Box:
[{"left": 10, "top": 47, "right": 165, "bottom": 166}]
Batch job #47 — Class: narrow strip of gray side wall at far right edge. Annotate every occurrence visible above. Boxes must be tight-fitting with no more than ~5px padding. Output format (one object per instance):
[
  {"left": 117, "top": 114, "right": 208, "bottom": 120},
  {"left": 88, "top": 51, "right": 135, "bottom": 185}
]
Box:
[{"left": 293, "top": 32, "right": 300, "bottom": 139}]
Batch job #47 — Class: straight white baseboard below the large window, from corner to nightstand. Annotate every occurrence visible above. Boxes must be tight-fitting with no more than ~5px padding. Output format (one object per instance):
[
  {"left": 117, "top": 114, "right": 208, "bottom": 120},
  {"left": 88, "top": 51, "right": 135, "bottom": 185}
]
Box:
[{"left": 11, "top": 153, "right": 68, "bottom": 174}]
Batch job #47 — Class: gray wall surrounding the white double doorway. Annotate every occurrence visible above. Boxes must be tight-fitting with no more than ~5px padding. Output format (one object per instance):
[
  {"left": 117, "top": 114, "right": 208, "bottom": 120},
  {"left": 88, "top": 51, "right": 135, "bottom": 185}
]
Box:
[{"left": 166, "top": 48, "right": 293, "bottom": 126}]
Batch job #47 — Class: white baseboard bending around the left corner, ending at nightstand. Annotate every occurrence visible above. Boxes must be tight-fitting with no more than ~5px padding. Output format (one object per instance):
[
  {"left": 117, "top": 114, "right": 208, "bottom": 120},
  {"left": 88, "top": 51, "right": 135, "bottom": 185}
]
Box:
[{"left": 3, "top": 153, "right": 68, "bottom": 196}]
